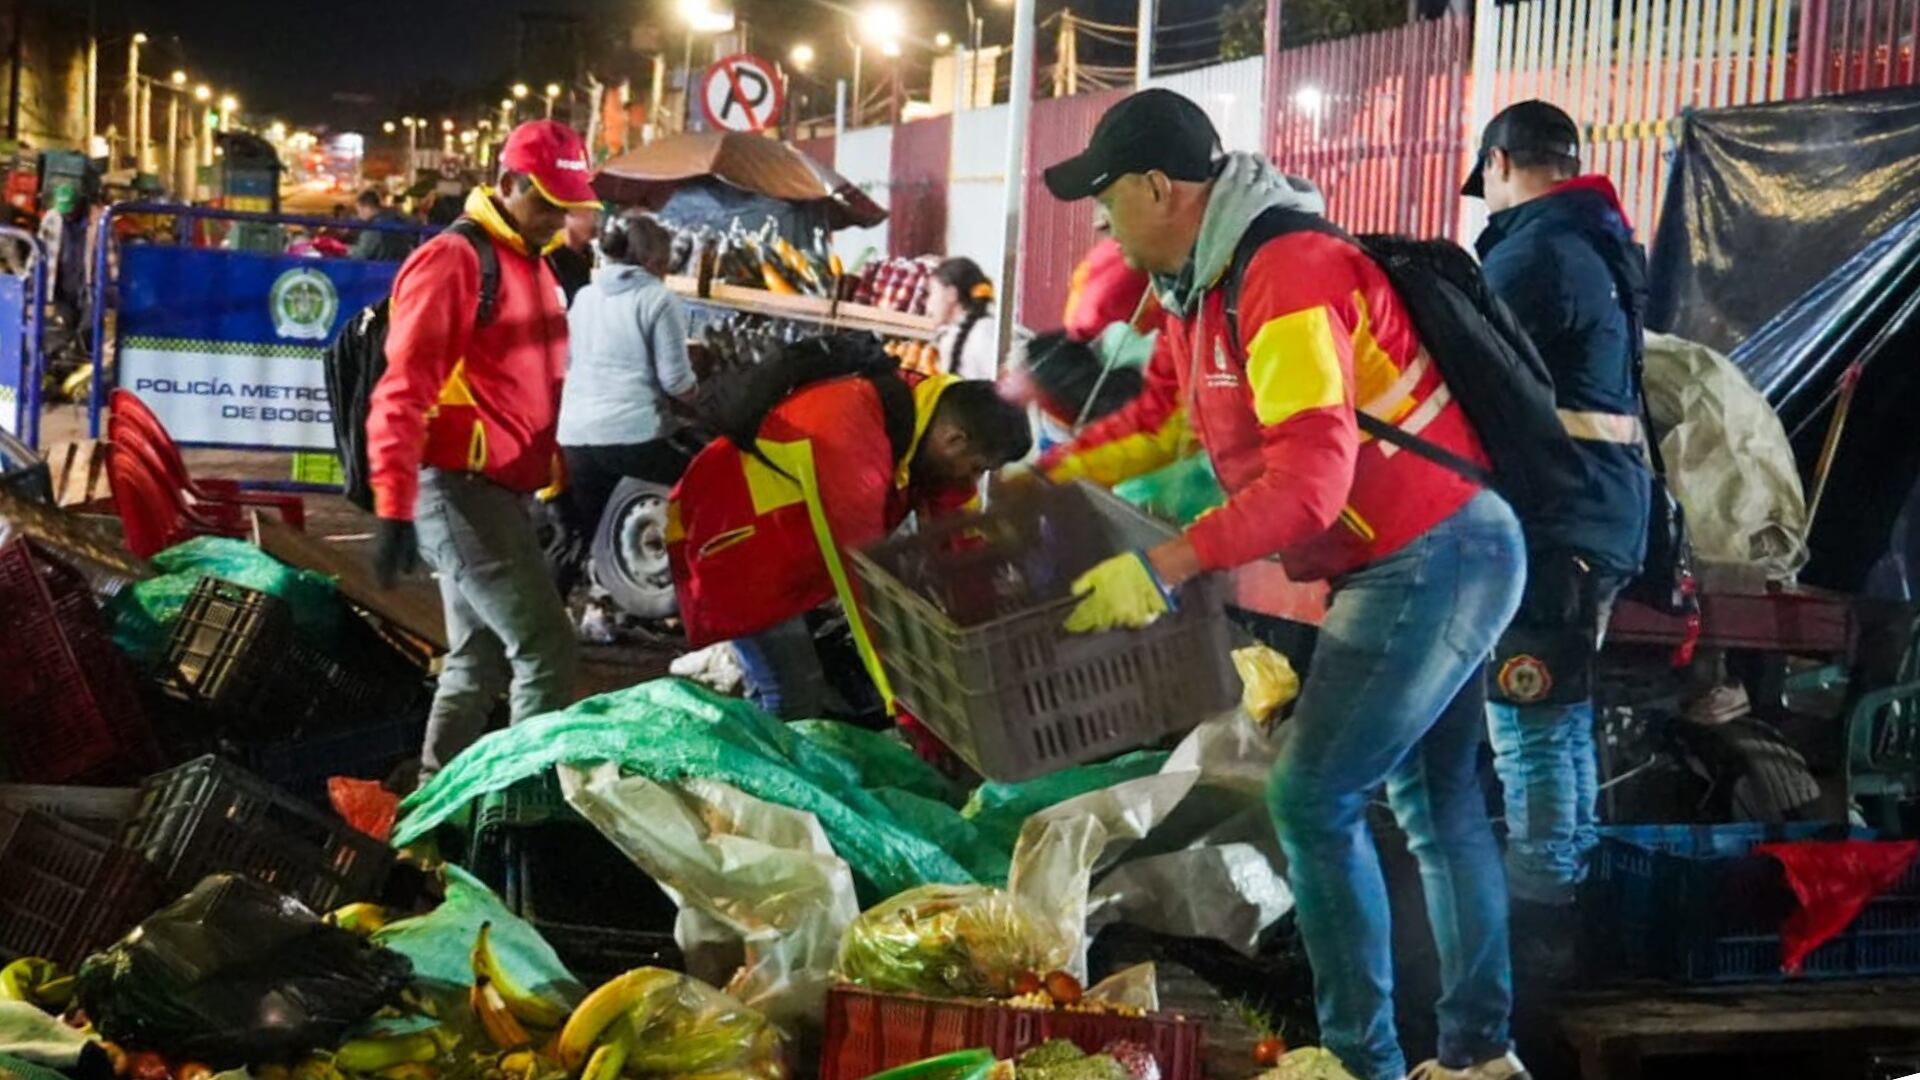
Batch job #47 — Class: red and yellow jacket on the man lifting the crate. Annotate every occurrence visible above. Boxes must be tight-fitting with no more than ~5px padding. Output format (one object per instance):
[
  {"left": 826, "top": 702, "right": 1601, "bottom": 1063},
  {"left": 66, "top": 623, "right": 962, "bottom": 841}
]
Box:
[{"left": 1041, "top": 233, "right": 1486, "bottom": 580}]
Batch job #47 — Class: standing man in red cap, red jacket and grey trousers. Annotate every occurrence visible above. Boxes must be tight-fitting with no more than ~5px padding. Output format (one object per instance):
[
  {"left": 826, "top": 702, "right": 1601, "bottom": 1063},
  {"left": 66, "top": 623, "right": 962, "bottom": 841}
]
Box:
[{"left": 367, "top": 121, "right": 599, "bottom": 782}]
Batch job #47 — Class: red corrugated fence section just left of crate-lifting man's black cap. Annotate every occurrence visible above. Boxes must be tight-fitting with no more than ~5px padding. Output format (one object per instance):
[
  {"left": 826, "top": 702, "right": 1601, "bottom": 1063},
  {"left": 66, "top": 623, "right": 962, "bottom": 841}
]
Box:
[{"left": 1016, "top": 90, "right": 1127, "bottom": 331}]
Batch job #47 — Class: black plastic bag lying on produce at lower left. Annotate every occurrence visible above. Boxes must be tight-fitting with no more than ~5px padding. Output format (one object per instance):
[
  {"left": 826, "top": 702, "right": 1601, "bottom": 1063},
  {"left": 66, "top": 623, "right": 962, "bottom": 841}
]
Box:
[{"left": 79, "top": 874, "right": 413, "bottom": 1068}]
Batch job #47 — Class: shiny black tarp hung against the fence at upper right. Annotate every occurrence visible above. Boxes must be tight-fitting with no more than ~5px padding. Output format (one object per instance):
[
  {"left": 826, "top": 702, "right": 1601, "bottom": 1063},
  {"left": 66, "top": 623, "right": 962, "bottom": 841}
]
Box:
[{"left": 1647, "top": 86, "right": 1920, "bottom": 352}]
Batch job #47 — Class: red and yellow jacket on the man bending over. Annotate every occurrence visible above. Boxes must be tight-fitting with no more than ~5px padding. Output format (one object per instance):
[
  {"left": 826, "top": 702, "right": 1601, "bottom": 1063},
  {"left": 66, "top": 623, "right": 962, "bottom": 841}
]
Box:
[{"left": 666, "top": 375, "right": 973, "bottom": 655}]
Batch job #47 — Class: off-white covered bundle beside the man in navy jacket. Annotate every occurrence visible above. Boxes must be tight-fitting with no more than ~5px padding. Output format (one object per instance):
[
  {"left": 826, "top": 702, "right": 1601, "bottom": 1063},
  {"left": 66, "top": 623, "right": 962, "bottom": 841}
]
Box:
[{"left": 1645, "top": 334, "right": 1807, "bottom": 580}]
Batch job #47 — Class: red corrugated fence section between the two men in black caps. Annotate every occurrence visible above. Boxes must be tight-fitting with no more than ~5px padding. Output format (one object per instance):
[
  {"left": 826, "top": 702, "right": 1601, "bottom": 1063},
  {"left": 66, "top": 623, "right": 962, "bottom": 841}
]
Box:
[{"left": 1274, "top": 15, "right": 1471, "bottom": 236}]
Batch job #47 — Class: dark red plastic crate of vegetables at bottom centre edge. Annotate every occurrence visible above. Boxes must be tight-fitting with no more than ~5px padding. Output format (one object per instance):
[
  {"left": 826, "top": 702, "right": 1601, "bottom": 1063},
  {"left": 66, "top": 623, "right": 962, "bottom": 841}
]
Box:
[{"left": 820, "top": 986, "right": 1206, "bottom": 1080}]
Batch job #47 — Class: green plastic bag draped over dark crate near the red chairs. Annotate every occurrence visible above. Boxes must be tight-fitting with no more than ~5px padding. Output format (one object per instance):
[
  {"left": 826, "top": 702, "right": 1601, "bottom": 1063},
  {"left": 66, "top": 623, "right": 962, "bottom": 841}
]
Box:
[{"left": 106, "top": 536, "right": 344, "bottom": 665}]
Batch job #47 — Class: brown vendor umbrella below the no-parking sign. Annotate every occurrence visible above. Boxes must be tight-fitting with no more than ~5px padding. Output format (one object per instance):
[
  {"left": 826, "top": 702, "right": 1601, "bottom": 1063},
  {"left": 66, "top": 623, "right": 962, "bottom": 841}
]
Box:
[{"left": 593, "top": 131, "right": 887, "bottom": 229}]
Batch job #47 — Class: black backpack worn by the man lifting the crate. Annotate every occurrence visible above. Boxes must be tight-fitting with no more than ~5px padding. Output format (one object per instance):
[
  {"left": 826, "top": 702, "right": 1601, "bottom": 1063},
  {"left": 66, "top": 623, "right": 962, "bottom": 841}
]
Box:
[{"left": 1225, "top": 208, "right": 1590, "bottom": 549}]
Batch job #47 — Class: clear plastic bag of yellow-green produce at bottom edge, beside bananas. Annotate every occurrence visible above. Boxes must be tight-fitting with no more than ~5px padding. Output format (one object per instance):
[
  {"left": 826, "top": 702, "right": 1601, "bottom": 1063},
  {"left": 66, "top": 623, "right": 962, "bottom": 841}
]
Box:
[{"left": 557, "top": 967, "right": 789, "bottom": 1080}]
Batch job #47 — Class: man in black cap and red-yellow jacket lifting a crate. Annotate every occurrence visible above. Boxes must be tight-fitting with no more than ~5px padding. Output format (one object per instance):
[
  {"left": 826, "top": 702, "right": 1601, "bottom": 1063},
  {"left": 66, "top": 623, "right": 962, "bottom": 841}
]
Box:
[{"left": 1043, "top": 90, "right": 1526, "bottom": 1080}]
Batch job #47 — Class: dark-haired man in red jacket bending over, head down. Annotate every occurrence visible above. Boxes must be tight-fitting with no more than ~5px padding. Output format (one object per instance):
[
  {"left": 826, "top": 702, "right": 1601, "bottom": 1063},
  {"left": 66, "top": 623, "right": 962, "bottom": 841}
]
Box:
[{"left": 666, "top": 334, "right": 1033, "bottom": 719}]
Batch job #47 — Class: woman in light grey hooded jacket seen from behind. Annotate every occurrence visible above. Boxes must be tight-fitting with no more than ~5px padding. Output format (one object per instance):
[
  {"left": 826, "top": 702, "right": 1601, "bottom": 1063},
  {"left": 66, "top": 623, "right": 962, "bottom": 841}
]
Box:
[{"left": 559, "top": 209, "right": 695, "bottom": 538}]
